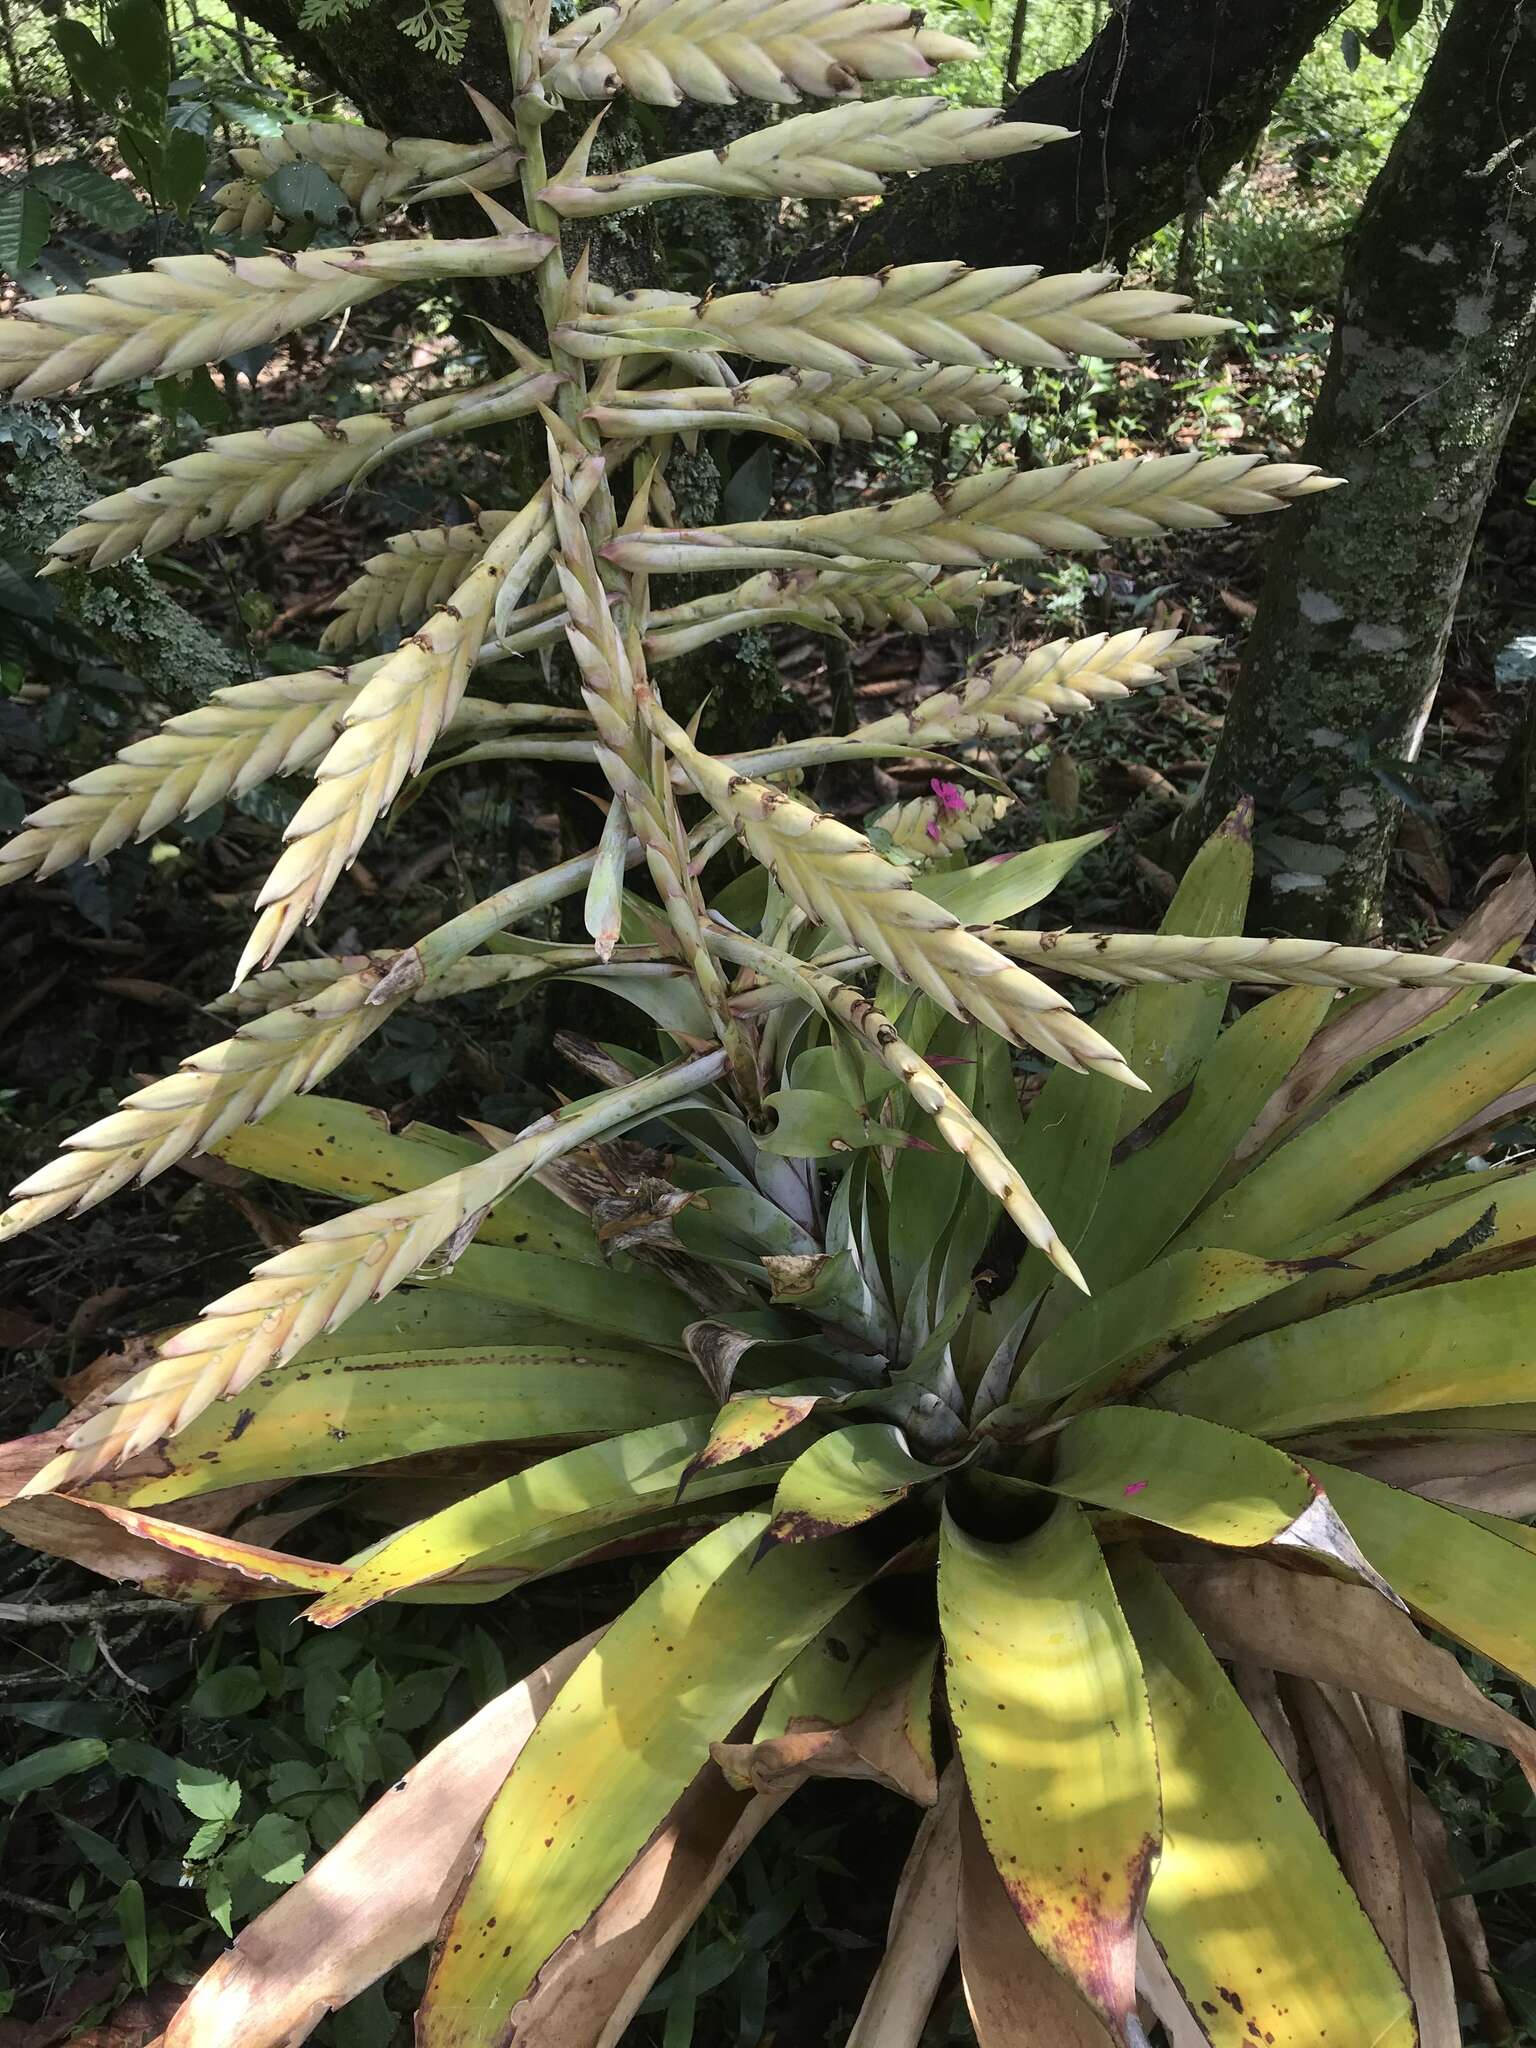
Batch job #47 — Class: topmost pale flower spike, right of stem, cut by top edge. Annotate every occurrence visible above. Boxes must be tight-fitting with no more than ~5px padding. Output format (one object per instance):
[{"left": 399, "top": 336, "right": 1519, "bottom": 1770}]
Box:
[{"left": 543, "top": 0, "right": 977, "bottom": 106}]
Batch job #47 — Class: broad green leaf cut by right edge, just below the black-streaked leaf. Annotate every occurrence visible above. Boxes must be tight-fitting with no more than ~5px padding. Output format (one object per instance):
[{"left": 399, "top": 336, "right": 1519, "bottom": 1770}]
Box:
[{"left": 1149, "top": 1268, "right": 1536, "bottom": 1436}]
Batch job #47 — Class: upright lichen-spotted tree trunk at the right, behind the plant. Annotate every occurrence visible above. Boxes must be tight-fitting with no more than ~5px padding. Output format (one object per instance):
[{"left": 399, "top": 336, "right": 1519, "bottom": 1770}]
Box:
[{"left": 1190, "top": 0, "right": 1536, "bottom": 940}]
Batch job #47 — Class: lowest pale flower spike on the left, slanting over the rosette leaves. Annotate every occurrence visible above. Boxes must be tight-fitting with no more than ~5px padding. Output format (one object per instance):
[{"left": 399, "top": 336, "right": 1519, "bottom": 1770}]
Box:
[{"left": 25, "top": 1053, "right": 725, "bottom": 1493}]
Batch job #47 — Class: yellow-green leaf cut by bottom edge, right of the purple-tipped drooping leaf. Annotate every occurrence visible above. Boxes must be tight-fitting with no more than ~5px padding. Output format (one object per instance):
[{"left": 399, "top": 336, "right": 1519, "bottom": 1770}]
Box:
[{"left": 1114, "top": 1550, "right": 1417, "bottom": 2048}]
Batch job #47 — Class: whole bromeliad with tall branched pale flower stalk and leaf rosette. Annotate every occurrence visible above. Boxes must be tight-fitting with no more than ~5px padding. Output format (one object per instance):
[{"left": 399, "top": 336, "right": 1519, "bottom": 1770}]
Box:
[{"left": 0, "top": 0, "right": 1536, "bottom": 2048}]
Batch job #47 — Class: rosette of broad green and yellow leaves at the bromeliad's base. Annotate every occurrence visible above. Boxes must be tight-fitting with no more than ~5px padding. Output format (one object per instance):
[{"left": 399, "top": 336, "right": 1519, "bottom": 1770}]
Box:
[{"left": 0, "top": 815, "right": 1536, "bottom": 2048}]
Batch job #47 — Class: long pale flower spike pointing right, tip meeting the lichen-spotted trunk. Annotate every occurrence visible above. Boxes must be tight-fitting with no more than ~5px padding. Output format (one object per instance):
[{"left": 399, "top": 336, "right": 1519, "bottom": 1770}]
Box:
[{"left": 604, "top": 455, "right": 1339, "bottom": 569}]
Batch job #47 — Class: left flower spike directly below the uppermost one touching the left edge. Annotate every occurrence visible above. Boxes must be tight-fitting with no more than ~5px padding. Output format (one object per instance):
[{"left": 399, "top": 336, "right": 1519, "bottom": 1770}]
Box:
[{"left": 43, "top": 371, "right": 561, "bottom": 573}]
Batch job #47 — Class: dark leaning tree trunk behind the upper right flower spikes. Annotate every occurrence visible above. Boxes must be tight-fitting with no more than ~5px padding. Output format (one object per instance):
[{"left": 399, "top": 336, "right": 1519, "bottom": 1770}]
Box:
[{"left": 846, "top": 0, "right": 1346, "bottom": 270}]
